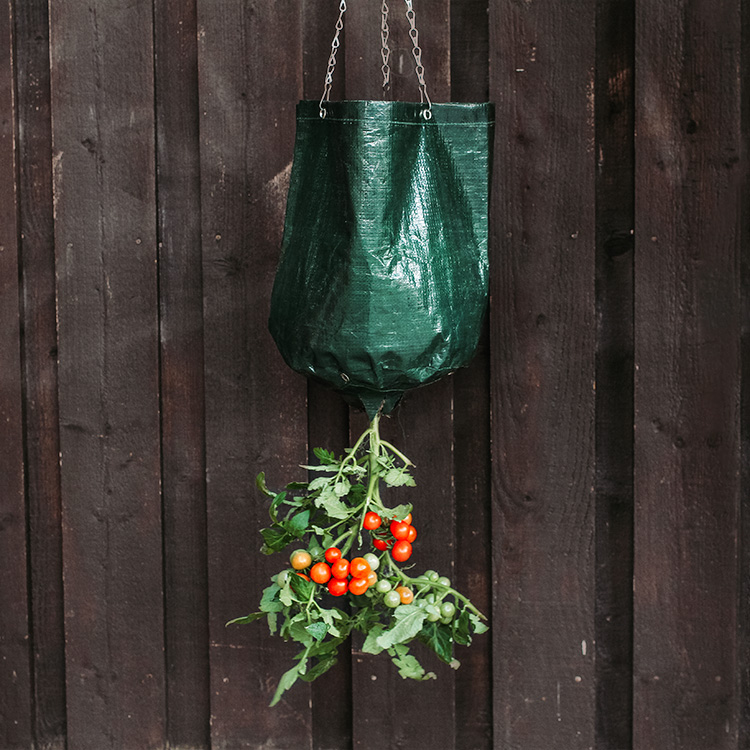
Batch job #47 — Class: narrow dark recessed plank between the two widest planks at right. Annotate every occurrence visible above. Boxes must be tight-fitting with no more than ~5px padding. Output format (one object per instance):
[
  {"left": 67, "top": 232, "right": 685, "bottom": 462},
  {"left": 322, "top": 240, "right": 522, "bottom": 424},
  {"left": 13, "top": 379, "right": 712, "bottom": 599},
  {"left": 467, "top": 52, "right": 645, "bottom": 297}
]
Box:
[{"left": 594, "top": 0, "right": 635, "bottom": 750}]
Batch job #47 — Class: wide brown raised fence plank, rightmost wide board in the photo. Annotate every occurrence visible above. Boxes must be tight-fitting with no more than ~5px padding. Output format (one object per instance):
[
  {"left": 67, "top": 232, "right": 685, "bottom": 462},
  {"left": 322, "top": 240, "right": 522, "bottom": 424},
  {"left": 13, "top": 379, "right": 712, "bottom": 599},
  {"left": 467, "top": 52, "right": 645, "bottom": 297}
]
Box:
[{"left": 633, "top": 0, "right": 744, "bottom": 750}]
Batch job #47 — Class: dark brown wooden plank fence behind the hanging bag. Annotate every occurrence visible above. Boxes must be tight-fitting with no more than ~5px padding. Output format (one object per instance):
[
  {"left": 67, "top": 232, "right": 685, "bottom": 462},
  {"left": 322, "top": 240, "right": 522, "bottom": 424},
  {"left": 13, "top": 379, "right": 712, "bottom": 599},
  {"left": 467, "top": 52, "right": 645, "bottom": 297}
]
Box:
[{"left": 0, "top": 0, "right": 750, "bottom": 750}]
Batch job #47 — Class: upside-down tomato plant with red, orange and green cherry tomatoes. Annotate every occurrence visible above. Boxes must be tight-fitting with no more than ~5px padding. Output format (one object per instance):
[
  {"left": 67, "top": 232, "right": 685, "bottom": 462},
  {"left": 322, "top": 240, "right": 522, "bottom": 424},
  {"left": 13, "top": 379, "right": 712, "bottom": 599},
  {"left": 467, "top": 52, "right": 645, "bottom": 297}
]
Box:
[{"left": 227, "top": 415, "right": 487, "bottom": 706}]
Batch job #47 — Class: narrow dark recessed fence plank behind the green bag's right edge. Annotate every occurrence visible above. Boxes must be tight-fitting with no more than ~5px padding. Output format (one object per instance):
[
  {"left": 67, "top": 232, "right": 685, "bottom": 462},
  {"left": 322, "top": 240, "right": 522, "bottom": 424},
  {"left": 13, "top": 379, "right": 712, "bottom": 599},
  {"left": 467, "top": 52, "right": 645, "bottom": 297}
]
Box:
[{"left": 450, "top": 0, "right": 492, "bottom": 750}]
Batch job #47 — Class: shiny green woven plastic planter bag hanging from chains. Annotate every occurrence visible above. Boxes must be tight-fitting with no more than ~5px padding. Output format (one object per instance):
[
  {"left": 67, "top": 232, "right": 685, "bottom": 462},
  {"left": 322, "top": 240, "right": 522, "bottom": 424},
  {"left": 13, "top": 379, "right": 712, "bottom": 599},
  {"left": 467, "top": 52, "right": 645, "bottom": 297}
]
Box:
[{"left": 269, "top": 101, "right": 494, "bottom": 417}]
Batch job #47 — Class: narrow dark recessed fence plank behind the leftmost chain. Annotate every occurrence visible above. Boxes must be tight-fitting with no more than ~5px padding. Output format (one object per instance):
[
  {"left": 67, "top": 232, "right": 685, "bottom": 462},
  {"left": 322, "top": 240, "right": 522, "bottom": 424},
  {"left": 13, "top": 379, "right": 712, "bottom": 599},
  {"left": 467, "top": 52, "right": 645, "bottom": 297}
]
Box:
[{"left": 302, "top": 0, "right": 352, "bottom": 748}]
